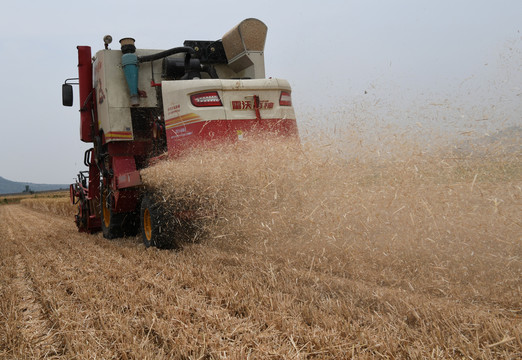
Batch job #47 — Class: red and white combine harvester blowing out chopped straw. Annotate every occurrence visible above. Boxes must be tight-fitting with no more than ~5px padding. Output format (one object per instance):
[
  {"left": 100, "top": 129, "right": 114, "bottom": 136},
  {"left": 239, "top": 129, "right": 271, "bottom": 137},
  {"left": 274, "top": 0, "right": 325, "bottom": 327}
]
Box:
[{"left": 62, "top": 19, "right": 298, "bottom": 247}]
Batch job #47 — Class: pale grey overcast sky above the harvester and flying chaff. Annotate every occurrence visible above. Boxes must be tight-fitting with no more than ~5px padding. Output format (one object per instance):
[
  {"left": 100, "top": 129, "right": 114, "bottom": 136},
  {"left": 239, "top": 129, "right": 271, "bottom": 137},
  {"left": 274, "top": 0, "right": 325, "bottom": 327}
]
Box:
[{"left": 0, "top": 0, "right": 522, "bottom": 183}]
